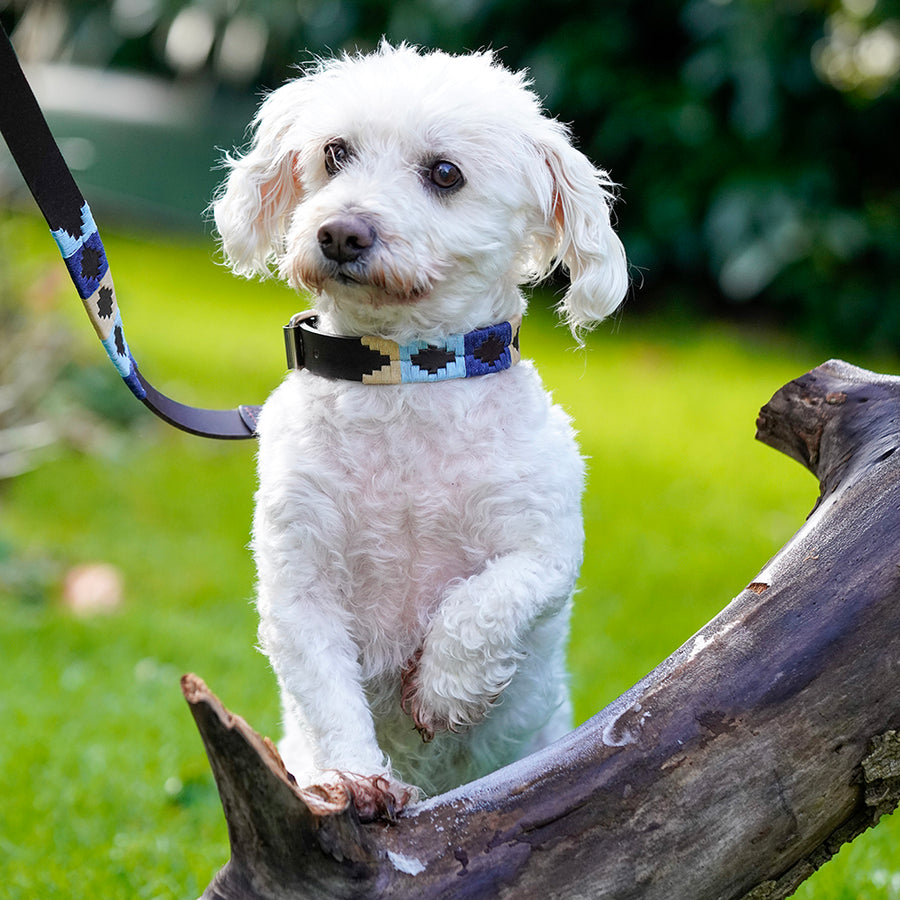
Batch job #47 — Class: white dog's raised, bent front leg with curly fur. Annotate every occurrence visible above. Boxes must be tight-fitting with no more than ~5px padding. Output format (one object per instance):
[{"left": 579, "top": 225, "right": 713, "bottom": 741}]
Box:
[{"left": 402, "top": 553, "right": 578, "bottom": 741}]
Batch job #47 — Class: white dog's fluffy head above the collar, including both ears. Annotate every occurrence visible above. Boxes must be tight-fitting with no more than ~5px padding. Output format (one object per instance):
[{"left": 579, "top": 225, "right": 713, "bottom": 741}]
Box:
[{"left": 213, "top": 43, "right": 628, "bottom": 338}]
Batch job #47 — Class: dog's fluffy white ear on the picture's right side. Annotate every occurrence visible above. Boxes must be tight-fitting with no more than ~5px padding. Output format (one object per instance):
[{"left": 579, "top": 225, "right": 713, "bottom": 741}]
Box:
[{"left": 541, "top": 128, "right": 628, "bottom": 335}]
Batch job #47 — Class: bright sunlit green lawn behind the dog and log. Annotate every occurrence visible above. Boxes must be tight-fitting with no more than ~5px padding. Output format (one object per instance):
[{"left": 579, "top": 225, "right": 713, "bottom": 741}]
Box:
[{"left": 0, "top": 214, "right": 900, "bottom": 900}]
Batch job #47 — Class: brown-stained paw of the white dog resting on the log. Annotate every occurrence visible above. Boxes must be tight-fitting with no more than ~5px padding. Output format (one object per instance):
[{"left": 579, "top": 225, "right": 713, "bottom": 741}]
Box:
[{"left": 301, "top": 771, "right": 419, "bottom": 822}]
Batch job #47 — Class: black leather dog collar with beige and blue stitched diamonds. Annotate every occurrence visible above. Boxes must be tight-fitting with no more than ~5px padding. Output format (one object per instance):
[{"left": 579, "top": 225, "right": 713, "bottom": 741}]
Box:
[{"left": 284, "top": 312, "right": 522, "bottom": 384}]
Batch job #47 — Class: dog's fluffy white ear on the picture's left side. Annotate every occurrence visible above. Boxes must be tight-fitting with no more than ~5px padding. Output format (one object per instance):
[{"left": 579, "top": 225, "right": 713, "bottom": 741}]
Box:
[{"left": 212, "top": 88, "right": 303, "bottom": 278}]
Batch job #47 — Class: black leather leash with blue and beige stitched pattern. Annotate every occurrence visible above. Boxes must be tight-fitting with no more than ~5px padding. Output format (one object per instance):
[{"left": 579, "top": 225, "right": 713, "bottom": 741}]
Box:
[{"left": 0, "top": 26, "right": 260, "bottom": 440}]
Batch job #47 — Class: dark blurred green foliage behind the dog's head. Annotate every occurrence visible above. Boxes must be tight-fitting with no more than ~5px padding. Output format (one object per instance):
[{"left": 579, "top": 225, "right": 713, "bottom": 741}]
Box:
[{"left": 2, "top": 0, "right": 900, "bottom": 350}]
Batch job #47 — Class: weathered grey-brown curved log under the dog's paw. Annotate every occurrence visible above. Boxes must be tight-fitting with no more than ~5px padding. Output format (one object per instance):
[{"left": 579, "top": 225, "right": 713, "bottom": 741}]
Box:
[{"left": 184, "top": 361, "right": 900, "bottom": 900}]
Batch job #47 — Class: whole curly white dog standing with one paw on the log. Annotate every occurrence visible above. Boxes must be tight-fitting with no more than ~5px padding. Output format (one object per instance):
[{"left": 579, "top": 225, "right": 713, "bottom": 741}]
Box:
[{"left": 213, "top": 44, "right": 627, "bottom": 816}]
